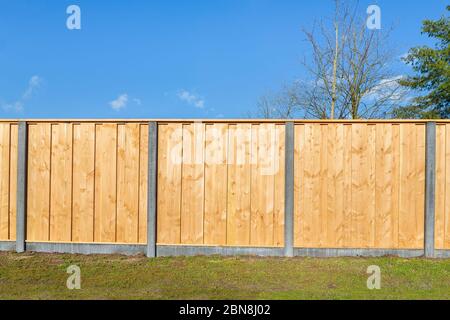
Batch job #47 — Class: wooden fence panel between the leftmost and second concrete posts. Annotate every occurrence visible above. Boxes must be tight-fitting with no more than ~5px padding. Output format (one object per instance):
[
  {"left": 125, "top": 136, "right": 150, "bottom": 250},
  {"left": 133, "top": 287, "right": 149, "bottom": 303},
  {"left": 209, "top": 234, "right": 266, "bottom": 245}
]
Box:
[{"left": 26, "top": 122, "right": 148, "bottom": 244}]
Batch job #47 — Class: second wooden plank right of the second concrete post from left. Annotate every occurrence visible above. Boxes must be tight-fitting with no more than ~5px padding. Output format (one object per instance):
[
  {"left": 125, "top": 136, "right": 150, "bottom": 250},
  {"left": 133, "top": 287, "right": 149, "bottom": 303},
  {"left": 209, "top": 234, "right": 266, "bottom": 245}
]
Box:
[{"left": 181, "top": 123, "right": 205, "bottom": 244}]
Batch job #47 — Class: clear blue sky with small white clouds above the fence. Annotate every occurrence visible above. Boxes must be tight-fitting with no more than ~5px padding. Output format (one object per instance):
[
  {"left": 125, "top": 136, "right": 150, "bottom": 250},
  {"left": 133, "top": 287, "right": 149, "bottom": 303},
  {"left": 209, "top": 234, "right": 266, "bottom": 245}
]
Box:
[{"left": 0, "top": 0, "right": 447, "bottom": 118}]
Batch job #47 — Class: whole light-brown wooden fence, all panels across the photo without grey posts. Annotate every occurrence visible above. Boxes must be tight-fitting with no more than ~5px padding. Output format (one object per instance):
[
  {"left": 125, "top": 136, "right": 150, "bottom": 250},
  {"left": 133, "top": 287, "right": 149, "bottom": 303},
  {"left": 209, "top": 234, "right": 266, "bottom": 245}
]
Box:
[{"left": 0, "top": 120, "right": 450, "bottom": 256}]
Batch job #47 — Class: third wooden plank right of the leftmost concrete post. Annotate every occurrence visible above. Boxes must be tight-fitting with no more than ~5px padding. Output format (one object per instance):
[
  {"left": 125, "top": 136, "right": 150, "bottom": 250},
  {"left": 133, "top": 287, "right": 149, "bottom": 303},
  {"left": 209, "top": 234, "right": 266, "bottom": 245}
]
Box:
[{"left": 72, "top": 123, "right": 95, "bottom": 242}]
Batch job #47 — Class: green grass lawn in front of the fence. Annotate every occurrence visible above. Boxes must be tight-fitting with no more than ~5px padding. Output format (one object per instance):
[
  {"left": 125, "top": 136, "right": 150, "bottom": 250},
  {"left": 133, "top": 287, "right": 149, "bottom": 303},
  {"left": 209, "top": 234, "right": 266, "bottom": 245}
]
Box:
[{"left": 0, "top": 253, "right": 450, "bottom": 299}]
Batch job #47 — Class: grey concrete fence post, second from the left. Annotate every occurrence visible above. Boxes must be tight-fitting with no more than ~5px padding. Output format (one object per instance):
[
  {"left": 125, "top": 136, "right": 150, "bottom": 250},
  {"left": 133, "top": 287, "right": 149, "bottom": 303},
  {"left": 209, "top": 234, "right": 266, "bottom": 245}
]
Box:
[{"left": 147, "top": 122, "right": 158, "bottom": 258}]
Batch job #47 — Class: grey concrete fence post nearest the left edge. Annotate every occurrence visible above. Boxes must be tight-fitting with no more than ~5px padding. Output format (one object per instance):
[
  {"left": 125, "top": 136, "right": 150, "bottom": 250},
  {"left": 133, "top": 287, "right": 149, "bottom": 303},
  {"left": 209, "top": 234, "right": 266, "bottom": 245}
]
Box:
[{"left": 16, "top": 121, "right": 28, "bottom": 253}]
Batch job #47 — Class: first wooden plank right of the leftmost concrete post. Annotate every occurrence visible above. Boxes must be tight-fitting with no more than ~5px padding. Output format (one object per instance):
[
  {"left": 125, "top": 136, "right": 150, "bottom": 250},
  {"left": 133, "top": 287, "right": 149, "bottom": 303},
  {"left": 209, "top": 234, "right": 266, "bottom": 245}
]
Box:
[{"left": 26, "top": 123, "right": 51, "bottom": 241}]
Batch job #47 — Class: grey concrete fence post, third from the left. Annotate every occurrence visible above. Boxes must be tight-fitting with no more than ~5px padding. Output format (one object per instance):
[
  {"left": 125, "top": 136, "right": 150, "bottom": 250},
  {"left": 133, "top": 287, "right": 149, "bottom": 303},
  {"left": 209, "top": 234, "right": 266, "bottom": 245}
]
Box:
[{"left": 284, "top": 122, "right": 294, "bottom": 257}]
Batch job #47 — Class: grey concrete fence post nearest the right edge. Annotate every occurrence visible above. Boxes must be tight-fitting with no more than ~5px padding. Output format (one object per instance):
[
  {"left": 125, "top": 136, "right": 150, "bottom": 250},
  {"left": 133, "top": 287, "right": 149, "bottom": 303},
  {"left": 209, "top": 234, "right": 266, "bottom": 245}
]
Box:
[{"left": 424, "top": 122, "right": 436, "bottom": 258}]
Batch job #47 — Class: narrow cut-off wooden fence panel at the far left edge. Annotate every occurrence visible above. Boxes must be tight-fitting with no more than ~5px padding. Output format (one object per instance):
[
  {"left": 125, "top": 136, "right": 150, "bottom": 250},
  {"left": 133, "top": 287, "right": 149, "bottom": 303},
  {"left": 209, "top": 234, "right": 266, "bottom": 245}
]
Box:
[{"left": 0, "top": 122, "right": 18, "bottom": 241}]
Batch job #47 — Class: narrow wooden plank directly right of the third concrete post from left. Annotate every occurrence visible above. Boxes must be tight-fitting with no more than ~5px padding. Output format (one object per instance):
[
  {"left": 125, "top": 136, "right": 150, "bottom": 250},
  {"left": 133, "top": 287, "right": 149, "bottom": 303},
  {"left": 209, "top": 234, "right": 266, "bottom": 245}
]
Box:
[{"left": 294, "top": 124, "right": 305, "bottom": 247}]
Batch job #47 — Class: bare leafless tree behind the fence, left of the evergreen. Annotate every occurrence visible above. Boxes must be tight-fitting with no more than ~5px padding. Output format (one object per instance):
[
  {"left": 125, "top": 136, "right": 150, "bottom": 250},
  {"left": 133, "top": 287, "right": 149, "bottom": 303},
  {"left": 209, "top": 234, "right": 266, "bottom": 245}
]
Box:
[{"left": 255, "top": 0, "right": 404, "bottom": 119}]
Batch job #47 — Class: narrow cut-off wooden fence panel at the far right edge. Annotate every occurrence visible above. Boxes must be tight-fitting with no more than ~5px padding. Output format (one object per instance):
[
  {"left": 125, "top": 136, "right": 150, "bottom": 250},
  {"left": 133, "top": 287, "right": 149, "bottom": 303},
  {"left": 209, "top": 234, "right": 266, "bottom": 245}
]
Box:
[{"left": 435, "top": 124, "right": 450, "bottom": 249}]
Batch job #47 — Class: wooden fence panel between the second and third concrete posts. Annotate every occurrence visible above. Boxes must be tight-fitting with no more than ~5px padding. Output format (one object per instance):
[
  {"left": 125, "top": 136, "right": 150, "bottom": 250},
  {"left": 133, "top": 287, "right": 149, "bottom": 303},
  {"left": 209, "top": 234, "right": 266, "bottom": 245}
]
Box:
[{"left": 157, "top": 123, "right": 285, "bottom": 247}]
